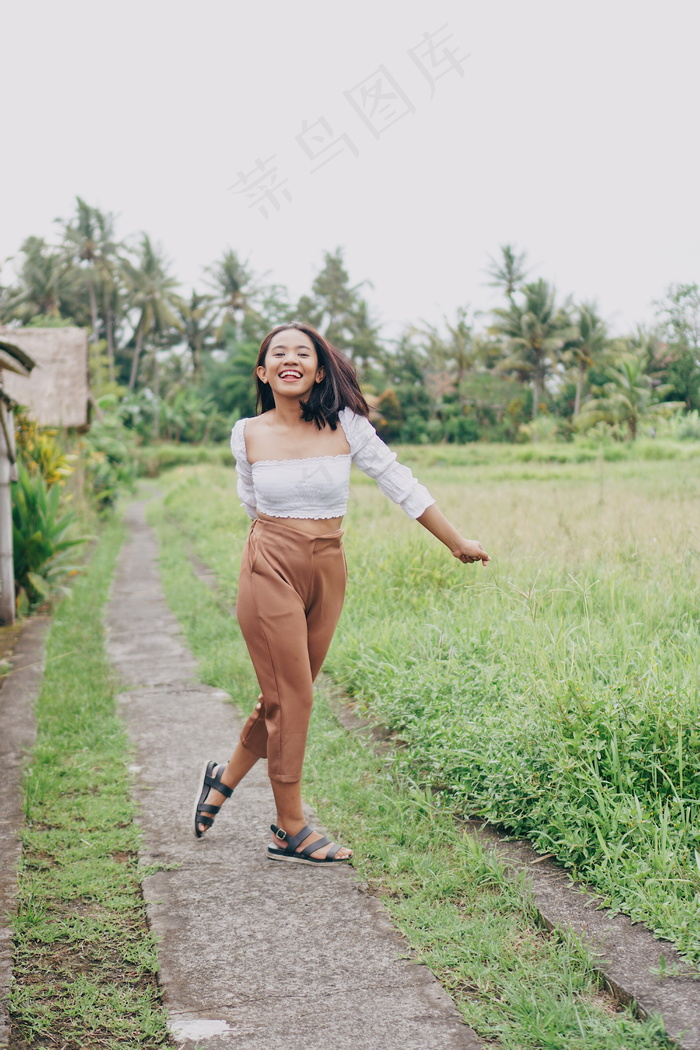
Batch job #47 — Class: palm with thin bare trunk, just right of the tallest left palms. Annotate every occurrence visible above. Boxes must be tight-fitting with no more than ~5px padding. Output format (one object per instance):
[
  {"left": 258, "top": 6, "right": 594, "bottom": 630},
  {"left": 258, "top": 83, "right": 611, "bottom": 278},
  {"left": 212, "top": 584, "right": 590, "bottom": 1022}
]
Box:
[{"left": 123, "top": 233, "right": 182, "bottom": 391}]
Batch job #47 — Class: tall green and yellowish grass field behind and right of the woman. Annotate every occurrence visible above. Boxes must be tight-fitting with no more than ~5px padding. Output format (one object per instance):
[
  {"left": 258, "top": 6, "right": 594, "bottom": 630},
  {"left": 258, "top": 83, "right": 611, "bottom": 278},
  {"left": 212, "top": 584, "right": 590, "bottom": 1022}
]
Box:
[{"left": 152, "top": 446, "right": 700, "bottom": 962}]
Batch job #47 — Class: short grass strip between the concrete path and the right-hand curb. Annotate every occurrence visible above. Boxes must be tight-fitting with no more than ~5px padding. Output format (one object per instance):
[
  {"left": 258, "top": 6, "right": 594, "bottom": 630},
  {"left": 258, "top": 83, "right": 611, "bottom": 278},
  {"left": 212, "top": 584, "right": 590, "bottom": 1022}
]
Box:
[{"left": 150, "top": 480, "right": 667, "bottom": 1050}]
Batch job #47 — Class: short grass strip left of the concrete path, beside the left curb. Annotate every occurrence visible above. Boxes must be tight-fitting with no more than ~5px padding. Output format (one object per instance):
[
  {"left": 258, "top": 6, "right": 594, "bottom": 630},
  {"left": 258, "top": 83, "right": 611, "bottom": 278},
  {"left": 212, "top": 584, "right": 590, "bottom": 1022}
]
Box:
[{"left": 10, "top": 522, "right": 168, "bottom": 1050}]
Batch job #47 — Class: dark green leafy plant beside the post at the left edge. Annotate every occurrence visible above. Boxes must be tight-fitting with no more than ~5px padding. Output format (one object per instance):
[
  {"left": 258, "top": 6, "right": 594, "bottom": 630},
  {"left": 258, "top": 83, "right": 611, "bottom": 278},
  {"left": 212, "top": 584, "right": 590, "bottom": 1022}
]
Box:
[{"left": 13, "top": 466, "right": 88, "bottom": 613}]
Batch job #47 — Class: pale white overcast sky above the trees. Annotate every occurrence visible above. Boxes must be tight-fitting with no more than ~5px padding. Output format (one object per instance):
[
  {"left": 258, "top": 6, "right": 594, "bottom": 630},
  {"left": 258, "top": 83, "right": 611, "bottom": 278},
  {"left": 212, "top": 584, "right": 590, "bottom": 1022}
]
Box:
[{"left": 0, "top": 0, "right": 700, "bottom": 335}]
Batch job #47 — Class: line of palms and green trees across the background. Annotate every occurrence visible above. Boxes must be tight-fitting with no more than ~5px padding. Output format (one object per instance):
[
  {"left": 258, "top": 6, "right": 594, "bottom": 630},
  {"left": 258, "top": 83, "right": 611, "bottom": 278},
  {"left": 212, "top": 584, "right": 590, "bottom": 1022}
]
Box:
[{"left": 0, "top": 197, "right": 700, "bottom": 442}]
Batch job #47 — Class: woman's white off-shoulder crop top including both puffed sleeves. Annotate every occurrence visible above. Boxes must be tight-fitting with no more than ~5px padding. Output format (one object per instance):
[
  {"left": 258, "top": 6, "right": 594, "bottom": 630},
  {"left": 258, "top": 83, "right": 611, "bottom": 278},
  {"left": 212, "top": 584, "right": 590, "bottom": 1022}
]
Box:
[{"left": 231, "top": 408, "right": 436, "bottom": 518}]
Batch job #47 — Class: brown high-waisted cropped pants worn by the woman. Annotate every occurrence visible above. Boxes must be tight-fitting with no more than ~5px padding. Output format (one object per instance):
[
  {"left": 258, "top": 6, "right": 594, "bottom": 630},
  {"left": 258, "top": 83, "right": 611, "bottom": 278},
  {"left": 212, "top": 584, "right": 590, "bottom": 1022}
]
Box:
[{"left": 236, "top": 519, "right": 347, "bottom": 783}]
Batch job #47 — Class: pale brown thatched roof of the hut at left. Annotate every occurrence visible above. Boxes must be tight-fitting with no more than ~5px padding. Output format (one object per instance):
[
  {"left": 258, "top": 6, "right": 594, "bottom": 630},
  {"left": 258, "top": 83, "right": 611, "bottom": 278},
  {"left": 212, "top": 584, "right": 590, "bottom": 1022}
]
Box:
[{"left": 0, "top": 327, "right": 89, "bottom": 426}]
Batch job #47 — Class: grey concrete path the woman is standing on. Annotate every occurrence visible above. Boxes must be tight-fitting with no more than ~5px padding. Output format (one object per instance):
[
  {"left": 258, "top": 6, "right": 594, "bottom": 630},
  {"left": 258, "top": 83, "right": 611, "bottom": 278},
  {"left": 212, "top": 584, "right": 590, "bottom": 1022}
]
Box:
[{"left": 107, "top": 502, "right": 484, "bottom": 1050}]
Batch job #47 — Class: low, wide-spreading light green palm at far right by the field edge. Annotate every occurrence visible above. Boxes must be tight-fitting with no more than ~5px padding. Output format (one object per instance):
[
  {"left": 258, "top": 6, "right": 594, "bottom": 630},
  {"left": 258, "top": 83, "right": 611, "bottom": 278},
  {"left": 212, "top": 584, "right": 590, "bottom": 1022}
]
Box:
[{"left": 580, "top": 354, "right": 683, "bottom": 441}]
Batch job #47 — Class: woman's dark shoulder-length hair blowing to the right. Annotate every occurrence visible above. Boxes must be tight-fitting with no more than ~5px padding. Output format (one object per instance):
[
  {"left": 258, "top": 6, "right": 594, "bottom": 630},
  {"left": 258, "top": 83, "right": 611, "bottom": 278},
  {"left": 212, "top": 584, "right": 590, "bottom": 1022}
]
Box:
[{"left": 255, "top": 321, "right": 369, "bottom": 431}]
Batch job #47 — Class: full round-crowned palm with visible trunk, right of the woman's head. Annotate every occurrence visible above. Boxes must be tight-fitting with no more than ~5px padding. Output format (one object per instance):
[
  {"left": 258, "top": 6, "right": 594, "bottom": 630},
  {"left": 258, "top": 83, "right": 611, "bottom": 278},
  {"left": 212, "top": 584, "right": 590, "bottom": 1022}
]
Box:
[{"left": 492, "top": 277, "right": 576, "bottom": 419}]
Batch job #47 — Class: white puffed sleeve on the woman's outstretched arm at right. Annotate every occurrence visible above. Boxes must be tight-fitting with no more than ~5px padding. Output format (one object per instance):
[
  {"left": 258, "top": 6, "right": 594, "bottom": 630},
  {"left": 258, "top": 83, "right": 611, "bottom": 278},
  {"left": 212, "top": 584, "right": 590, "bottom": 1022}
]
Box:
[{"left": 339, "top": 408, "right": 436, "bottom": 518}]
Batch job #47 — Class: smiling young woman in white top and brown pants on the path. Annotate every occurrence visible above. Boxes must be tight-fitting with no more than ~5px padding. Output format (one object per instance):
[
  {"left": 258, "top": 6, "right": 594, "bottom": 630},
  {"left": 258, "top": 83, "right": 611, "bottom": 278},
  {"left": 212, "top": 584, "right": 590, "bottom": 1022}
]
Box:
[{"left": 194, "top": 321, "right": 489, "bottom": 864}]
